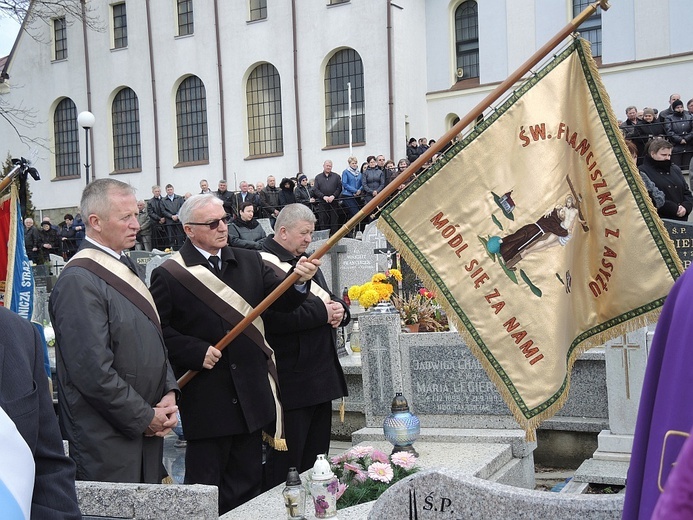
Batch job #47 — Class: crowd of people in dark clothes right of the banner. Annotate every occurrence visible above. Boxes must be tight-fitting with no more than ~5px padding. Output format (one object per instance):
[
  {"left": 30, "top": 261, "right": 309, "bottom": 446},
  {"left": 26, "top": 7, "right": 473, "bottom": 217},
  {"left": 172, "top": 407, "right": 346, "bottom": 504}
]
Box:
[{"left": 620, "top": 94, "right": 693, "bottom": 221}]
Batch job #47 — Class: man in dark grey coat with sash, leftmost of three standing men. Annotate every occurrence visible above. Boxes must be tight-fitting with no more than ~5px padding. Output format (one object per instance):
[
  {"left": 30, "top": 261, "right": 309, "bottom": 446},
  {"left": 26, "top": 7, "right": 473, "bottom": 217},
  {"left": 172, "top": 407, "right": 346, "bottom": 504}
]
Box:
[{"left": 49, "top": 179, "right": 178, "bottom": 483}]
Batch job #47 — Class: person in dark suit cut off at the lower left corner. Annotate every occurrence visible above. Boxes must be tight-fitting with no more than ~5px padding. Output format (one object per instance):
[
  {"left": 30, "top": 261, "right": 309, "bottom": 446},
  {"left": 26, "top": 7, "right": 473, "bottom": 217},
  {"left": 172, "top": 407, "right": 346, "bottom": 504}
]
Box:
[{"left": 0, "top": 307, "right": 81, "bottom": 520}]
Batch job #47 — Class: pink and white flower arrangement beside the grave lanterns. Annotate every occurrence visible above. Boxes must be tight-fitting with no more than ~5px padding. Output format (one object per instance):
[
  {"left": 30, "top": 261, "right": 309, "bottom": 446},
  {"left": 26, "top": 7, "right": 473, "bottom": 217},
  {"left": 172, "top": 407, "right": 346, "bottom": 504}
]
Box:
[{"left": 331, "top": 446, "right": 419, "bottom": 509}]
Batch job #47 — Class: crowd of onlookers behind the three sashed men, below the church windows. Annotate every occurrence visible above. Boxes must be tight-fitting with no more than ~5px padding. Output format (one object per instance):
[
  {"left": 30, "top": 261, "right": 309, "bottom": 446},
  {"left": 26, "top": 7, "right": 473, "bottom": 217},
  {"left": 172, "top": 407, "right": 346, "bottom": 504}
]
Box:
[{"left": 137, "top": 146, "right": 434, "bottom": 251}]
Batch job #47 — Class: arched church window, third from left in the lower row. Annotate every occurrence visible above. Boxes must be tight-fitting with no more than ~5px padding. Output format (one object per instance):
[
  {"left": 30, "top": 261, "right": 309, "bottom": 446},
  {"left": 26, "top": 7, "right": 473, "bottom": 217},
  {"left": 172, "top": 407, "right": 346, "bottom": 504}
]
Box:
[{"left": 176, "top": 76, "right": 209, "bottom": 163}]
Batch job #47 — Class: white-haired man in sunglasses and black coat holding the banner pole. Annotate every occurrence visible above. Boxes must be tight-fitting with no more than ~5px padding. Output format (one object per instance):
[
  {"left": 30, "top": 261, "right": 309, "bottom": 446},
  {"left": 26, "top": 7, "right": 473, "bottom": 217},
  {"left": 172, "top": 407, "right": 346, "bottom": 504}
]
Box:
[{"left": 151, "top": 195, "right": 320, "bottom": 515}]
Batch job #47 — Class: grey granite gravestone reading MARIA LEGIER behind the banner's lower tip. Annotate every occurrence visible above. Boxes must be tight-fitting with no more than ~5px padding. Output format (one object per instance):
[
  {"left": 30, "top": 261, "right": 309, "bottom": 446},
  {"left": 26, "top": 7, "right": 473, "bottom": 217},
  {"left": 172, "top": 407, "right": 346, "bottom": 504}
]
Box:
[{"left": 359, "top": 313, "right": 608, "bottom": 433}]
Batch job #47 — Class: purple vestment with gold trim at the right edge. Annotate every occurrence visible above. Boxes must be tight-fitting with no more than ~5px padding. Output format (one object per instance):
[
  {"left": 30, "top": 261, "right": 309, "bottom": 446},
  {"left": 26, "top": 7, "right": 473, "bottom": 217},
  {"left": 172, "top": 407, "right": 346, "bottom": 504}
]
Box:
[{"left": 623, "top": 271, "right": 693, "bottom": 520}]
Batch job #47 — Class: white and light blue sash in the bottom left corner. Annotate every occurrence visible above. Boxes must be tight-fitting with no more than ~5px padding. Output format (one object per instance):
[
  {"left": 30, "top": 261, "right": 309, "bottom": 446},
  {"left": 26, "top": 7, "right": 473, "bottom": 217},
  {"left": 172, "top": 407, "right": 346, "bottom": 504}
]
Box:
[{"left": 0, "top": 407, "right": 35, "bottom": 520}]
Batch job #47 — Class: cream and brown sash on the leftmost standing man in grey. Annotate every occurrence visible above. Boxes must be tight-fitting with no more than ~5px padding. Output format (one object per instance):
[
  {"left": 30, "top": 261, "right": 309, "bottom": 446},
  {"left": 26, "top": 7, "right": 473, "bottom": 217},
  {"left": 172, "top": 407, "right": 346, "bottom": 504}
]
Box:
[{"left": 65, "top": 248, "right": 163, "bottom": 336}]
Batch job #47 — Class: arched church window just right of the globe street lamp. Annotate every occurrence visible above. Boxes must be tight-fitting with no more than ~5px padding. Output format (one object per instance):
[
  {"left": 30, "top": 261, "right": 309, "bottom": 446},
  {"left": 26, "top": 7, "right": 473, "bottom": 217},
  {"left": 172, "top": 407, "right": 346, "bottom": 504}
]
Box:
[{"left": 111, "top": 87, "right": 142, "bottom": 171}]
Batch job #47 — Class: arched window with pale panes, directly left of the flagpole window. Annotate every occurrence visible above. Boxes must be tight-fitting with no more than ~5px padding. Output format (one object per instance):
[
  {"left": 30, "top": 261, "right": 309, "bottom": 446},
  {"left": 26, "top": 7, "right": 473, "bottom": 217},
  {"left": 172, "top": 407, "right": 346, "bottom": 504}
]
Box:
[{"left": 245, "top": 63, "right": 284, "bottom": 156}]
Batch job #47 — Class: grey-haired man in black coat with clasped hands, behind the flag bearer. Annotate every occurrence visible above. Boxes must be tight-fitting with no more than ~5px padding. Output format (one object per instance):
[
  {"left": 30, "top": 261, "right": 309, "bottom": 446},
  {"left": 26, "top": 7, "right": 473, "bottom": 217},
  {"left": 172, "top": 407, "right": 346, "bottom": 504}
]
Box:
[{"left": 260, "top": 204, "right": 349, "bottom": 488}]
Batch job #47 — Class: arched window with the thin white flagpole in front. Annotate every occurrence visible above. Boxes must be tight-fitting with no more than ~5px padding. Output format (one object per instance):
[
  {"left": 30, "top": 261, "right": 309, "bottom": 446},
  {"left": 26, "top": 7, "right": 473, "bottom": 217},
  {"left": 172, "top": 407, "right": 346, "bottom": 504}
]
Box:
[{"left": 325, "top": 49, "right": 366, "bottom": 146}]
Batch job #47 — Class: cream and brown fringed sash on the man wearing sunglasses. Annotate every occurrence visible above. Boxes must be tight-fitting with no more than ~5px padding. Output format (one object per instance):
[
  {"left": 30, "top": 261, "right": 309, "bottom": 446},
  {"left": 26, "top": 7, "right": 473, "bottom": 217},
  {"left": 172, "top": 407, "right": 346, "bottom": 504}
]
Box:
[{"left": 161, "top": 253, "right": 287, "bottom": 451}]
